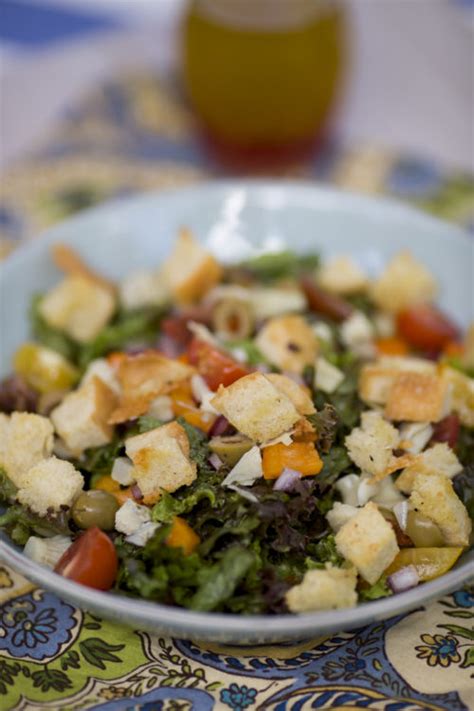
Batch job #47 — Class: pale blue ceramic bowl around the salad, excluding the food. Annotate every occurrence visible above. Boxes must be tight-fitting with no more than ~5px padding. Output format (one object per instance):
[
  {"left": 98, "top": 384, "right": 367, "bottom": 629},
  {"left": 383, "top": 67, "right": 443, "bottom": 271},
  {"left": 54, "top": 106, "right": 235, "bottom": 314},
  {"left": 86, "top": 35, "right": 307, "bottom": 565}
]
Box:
[{"left": 0, "top": 181, "right": 474, "bottom": 644}]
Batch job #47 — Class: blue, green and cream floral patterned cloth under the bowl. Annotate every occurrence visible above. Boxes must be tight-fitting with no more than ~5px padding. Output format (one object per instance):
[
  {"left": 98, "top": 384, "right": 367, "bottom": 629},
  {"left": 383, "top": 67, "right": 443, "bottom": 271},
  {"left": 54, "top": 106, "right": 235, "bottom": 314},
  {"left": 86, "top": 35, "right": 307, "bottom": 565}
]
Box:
[{"left": 0, "top": 76, "right": 474, "bottom": 711}]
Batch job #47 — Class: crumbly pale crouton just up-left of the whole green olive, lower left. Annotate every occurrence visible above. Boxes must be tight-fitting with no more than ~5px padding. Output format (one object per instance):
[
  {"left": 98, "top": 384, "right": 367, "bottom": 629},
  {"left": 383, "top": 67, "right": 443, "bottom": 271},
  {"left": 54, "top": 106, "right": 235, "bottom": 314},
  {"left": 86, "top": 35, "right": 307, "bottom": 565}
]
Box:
[{"left": 17, "top": 457, "right": 84, "bottom": 516}]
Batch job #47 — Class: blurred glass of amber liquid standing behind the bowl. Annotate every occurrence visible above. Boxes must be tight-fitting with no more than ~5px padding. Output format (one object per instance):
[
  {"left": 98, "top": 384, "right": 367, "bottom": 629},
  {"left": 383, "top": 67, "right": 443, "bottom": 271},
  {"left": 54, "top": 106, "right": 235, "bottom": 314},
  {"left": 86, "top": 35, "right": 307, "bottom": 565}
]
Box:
[{"left": 183, "top": 0, "right": 345, "bottom": 164}]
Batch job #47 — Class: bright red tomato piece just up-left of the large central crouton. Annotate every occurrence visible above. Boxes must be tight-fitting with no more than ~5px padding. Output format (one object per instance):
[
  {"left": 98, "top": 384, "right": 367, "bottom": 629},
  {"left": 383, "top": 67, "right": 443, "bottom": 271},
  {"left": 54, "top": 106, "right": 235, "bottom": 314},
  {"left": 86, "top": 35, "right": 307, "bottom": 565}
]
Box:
[{"left": 188, "top": 338, "right": 252, "bottom": 390}]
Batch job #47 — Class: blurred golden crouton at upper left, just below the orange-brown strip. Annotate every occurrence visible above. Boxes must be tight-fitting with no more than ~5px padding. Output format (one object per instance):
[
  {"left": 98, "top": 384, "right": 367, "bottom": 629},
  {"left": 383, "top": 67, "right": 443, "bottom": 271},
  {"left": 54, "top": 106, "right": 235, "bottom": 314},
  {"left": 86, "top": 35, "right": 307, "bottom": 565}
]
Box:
[{"left": 39, "top": 276, "right": 115, "bottom": 343}]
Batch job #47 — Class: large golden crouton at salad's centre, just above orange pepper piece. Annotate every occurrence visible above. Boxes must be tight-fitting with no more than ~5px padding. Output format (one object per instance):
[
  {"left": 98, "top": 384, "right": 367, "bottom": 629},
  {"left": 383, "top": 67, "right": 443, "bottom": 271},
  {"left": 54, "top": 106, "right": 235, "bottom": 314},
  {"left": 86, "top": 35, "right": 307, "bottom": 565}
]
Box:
[{"left": 211, "top": 373, "right": 300, "bottom": 442}]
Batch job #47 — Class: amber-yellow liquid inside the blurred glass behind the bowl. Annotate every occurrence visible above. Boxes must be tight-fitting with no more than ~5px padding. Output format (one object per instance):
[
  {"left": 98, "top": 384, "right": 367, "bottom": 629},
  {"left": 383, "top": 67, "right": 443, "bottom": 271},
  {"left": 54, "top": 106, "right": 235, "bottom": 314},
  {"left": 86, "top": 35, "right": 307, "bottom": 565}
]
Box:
[{"left": 184, "top": 0, "right": 344, "bottom": 159}]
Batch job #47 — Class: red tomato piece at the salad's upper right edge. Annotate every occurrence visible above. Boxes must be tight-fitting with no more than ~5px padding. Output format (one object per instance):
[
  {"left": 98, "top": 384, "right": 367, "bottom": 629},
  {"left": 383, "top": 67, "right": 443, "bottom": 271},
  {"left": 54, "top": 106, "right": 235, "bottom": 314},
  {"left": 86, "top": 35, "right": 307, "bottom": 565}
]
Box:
[{"left": 397, "top": 304, "right": 459, "bottom": 351}]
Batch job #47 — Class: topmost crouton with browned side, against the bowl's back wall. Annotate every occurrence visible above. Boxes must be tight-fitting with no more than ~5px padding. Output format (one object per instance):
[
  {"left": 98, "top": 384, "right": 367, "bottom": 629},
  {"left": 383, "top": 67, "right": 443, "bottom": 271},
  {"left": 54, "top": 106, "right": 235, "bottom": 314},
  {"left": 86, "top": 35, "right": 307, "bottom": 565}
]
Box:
[{"left": 160, "top": 229, "right": 223, "bottom": 303}]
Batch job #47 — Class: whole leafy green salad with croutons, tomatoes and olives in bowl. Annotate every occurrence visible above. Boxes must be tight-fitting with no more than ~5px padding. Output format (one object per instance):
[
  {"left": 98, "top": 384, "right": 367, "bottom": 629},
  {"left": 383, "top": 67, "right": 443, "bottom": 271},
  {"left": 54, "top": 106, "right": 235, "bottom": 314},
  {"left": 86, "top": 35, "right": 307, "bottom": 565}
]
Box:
[{"left": 0, "top": 230, "right": 474, "bottom": 615}]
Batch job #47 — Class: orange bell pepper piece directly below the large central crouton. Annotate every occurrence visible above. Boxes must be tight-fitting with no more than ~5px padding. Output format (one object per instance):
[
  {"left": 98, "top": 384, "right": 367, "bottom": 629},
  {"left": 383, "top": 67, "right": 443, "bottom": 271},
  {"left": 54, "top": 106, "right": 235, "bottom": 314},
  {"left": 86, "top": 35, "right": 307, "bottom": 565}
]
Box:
[{"left": 262, "top": 442, "right": 323, "bottom": 479}]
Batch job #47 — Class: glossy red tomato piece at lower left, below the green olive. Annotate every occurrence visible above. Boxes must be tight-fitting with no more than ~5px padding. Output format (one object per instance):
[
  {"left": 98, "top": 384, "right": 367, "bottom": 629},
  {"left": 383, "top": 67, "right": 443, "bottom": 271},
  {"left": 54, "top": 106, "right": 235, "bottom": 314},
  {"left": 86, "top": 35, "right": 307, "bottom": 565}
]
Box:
[{"left": 54, "top": 527, "right": 118, "bottom": 590}]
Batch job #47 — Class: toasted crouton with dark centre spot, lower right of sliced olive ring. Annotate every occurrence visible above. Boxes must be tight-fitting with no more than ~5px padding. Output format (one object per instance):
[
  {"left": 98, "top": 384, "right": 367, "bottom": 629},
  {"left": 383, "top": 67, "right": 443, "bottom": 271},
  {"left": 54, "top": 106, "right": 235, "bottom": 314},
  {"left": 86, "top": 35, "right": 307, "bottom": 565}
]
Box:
[{"left": 255, "top": 315, "right": 318, "bottom": 373}]
